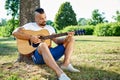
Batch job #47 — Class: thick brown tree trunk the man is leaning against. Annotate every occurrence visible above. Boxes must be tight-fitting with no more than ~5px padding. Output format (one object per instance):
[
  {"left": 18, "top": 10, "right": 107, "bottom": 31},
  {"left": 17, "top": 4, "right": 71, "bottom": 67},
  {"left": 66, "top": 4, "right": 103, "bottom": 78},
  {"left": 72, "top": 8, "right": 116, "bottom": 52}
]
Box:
[{"left": 17, "top": 0, "right": 40, "bottom": 63}]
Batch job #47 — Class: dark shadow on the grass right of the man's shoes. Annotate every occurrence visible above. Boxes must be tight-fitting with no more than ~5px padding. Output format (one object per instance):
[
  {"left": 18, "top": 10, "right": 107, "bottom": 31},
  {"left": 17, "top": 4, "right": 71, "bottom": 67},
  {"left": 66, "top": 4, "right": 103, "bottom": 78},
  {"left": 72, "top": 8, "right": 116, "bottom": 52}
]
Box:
[{"left": 65, "top": 66, "right": 120, "bottom": 80}]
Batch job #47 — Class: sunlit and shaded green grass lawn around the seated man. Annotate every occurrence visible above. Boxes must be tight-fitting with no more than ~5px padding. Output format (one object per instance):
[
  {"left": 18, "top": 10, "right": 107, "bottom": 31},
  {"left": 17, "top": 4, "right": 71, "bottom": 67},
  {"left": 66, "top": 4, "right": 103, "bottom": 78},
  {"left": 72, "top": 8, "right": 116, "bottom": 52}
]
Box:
[{"left": 0, "top": 36, "right": 120, "bottom": 80}]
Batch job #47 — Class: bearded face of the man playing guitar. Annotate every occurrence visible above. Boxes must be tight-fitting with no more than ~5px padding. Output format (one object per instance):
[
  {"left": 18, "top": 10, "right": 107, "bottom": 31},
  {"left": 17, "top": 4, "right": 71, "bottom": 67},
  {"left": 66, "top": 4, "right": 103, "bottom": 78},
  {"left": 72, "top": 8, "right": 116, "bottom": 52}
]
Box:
[{"left": 35, "top": 13, "right": 46, "bottom": 26}]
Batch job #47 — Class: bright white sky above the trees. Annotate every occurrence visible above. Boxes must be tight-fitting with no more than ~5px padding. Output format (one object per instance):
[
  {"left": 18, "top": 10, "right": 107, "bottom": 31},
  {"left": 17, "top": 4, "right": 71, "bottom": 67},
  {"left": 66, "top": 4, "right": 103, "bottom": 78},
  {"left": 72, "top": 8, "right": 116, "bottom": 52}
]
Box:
[{"left": 0, "top": 0, "right": 120, "bottom": 21}]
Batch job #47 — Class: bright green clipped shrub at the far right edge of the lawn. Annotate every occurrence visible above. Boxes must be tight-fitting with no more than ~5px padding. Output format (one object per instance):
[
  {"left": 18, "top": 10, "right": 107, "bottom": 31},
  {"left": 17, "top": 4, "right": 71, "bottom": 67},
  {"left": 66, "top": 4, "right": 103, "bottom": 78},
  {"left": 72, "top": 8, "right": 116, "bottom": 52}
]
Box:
[{"left": 94, "top": 22, "right": 120, "bottom": 36}]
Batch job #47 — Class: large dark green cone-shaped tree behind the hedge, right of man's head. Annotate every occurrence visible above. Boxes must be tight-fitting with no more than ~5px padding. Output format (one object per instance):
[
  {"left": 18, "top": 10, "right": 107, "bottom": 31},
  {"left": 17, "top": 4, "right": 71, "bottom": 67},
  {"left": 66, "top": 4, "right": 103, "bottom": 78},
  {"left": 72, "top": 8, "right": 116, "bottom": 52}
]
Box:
[{"left": 54, "top": 2, "right": 77, "bottom": 30}]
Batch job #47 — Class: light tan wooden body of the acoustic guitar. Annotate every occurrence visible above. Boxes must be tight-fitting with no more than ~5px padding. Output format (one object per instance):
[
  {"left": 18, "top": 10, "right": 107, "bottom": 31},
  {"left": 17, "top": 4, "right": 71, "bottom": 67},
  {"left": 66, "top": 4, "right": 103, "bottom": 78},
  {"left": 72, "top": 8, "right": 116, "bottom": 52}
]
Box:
[{"left": 17, "top": 29, "right": 51, "bottom": 55}]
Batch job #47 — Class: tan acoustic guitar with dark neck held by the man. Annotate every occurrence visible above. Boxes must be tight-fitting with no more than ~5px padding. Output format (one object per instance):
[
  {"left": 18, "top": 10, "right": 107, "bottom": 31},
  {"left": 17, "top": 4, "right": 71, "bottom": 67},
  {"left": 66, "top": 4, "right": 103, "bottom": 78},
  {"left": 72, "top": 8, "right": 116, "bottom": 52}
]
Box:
[{"left": 16, "top": 29, "right": 84, "bottom": 55}]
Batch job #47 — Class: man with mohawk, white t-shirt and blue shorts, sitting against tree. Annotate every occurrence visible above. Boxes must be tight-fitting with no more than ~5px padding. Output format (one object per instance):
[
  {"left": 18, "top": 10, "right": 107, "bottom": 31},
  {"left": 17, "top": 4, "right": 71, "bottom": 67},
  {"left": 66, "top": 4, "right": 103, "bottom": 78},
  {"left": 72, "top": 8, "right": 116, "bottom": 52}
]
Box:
[{"left": 13, "top": 8, "right": 79, "bottom": 80}]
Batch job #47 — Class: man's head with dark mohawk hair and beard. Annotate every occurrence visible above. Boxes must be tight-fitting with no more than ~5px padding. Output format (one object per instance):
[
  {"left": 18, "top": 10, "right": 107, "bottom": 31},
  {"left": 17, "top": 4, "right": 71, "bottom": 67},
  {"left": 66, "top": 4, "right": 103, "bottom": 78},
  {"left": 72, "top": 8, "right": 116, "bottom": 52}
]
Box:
[{"left": 35, "top": 8, "right": 46, "bottom": 26}]
